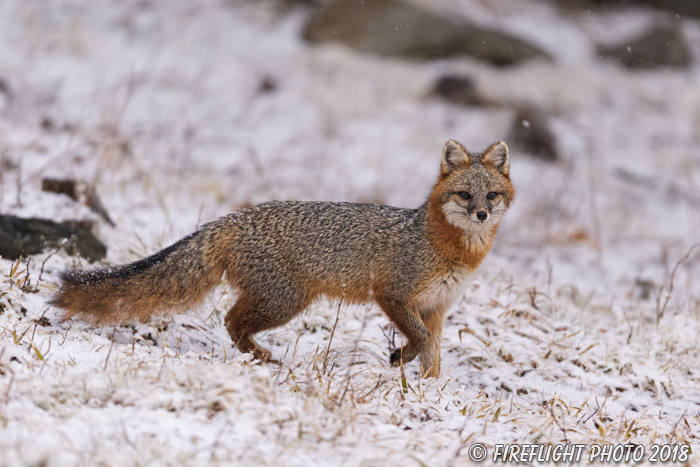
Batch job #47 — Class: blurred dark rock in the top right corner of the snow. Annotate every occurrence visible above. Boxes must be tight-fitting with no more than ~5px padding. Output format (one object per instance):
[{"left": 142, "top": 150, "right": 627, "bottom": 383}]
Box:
[{"left": 598, "top": 23, "right": 691, "bottom": 70}]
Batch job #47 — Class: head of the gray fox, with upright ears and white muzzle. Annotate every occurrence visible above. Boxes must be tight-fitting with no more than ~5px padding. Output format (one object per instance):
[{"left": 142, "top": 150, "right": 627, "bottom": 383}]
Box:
[{"left": 433, "top": 140, "right": 515, "bottom": 232}]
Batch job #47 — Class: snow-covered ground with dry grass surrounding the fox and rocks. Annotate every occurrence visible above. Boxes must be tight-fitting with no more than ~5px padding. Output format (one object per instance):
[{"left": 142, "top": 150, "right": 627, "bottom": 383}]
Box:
[{"left": 0, "top": 0, "right": 700, "bottom": 466}]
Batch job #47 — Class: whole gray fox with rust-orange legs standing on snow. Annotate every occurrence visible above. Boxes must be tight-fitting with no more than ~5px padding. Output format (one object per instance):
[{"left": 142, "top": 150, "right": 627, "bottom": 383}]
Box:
[{"left": 51, "top": 140, "right": 515, "bottom": 377}]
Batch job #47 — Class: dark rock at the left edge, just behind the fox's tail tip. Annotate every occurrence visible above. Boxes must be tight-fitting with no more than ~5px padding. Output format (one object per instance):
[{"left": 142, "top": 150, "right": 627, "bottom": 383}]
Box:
[{"left": 0, "top": 215, "right": 107, "bottom": 262}]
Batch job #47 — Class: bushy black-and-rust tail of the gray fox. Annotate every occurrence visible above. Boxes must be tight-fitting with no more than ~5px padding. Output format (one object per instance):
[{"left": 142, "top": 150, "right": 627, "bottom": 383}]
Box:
[{"left": 50, "top": 218, "right": 230, "bottom": 324}]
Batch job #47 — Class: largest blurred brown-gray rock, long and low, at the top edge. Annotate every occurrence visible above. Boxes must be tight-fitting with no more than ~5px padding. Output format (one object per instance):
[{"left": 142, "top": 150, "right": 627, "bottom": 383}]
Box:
[{"left": 303, "top": 0, "right": 551, "bottom": 65}]
